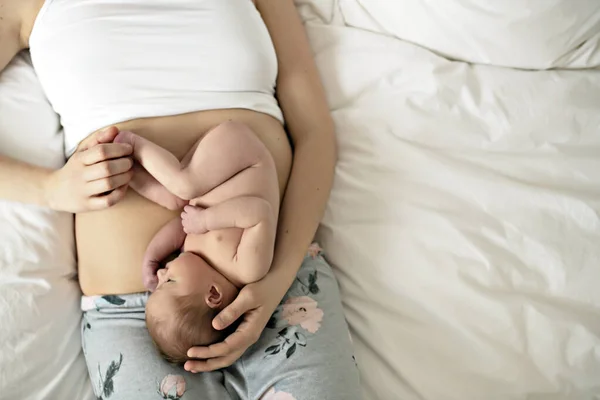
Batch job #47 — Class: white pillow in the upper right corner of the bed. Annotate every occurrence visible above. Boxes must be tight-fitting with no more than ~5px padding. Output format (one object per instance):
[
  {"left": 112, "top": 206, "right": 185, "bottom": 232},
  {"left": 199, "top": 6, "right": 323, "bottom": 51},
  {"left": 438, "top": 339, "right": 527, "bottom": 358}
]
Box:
[{"left": 340, "top": 0, "right": 600, "bottom": 69}]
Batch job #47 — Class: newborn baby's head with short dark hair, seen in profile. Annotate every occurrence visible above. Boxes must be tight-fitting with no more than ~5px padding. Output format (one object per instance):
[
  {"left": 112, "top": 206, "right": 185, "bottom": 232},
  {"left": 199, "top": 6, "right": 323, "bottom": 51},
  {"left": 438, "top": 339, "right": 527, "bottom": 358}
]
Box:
[{"left": 146, "top": 253, "right": 238, "bottom": 363}]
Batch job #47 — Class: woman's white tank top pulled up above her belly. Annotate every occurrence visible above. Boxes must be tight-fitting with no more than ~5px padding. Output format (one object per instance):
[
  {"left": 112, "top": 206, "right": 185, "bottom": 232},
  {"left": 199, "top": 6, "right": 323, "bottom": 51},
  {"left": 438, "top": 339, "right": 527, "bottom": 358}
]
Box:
[{"left": 30, "top": 0, "right": 283, "bottom": 155}]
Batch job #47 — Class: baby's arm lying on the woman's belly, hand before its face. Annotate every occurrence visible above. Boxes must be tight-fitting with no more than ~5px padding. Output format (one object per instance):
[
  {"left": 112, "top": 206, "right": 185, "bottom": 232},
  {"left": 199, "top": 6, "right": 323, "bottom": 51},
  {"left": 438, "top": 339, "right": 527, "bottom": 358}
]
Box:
[{"left": 142, "top": 217, "right": 186, "bottom": 291}]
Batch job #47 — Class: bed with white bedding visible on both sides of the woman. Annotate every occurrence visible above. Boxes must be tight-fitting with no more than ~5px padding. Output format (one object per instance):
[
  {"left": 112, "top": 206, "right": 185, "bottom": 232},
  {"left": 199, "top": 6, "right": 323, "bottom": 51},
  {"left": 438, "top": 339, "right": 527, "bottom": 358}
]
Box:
[{"left": 0, "top": 0, "right": 600, "bottom": 400}]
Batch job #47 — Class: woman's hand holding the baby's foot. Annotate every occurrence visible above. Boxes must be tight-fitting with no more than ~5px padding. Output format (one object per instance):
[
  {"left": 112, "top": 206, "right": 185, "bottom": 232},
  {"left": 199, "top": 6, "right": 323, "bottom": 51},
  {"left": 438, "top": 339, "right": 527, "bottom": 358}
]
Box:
[{"left": 45, "top": 127, "right": 133, "bottom": 213}]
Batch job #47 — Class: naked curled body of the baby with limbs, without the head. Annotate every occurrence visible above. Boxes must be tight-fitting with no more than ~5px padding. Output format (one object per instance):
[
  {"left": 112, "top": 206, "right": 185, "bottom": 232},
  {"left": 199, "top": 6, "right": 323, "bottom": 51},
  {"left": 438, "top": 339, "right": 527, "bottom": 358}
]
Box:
[{"left": 116, "top": 122, "right": 279, "bottom": 290}]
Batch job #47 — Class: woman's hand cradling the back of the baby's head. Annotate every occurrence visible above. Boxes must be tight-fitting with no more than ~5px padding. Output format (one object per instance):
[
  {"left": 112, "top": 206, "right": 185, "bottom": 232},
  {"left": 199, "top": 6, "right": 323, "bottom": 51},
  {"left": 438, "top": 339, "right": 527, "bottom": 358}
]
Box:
[{"left": 185, "top": 274, "right": 287, "bottom": 373}]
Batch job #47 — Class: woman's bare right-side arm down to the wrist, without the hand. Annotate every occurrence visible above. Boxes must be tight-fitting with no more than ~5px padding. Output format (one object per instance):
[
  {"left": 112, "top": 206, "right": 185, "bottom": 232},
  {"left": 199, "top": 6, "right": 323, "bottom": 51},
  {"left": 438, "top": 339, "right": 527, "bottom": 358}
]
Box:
[{"left": 256, "top": 0, "right": 336, "bottom": 290}]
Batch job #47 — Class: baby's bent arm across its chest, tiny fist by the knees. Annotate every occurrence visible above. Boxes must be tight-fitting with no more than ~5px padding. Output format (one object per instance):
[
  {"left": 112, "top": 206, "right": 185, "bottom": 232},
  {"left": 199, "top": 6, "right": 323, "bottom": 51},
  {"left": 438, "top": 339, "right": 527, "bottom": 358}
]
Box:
[{"left": 181, "top": 197, "right": 277, "bottom": 284}]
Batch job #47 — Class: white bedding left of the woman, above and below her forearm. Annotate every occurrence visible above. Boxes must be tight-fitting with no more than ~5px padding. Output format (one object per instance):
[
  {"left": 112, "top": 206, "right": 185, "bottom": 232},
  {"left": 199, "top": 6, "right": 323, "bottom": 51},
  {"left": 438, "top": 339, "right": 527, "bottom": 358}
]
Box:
[{"left": 0, "top": 53, "right": 94, "bottom": 400}]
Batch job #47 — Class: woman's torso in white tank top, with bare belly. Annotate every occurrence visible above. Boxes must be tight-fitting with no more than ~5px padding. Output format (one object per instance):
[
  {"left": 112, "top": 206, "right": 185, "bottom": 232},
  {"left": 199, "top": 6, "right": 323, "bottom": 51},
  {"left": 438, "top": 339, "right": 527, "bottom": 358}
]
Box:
[{"left": 29, "top": 0, "right": 291, "bottom": 295}]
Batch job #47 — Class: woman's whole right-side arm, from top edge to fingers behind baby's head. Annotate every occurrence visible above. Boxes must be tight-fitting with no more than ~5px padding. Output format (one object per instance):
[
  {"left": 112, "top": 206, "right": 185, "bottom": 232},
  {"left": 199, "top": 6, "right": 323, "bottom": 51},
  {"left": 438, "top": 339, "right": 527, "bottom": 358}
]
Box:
[{"left": 185, "top": 0, "right": 336, "bottom": 372}]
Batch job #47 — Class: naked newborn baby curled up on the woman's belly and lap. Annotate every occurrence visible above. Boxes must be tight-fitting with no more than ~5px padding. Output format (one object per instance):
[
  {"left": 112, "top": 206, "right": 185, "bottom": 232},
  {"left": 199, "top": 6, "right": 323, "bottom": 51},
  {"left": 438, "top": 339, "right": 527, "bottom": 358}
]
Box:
[{"left": 115, "top": 122, "right": 280, "bottom": 363}]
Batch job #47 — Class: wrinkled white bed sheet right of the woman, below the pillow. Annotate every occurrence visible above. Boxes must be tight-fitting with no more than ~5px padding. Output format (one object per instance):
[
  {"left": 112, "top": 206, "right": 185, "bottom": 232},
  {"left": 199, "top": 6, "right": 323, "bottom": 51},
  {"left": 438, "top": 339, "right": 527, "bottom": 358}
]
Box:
[{"left": 298, "top": 0, "right": 600, "bottom": 400}]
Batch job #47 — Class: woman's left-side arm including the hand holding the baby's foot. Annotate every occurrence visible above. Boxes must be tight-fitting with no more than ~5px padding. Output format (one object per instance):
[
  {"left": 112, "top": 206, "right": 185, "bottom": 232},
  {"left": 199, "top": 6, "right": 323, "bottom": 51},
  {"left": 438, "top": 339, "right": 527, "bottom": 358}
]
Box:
[{"left": 0, "top": 0, "right": 132, "bottom": 212}]
